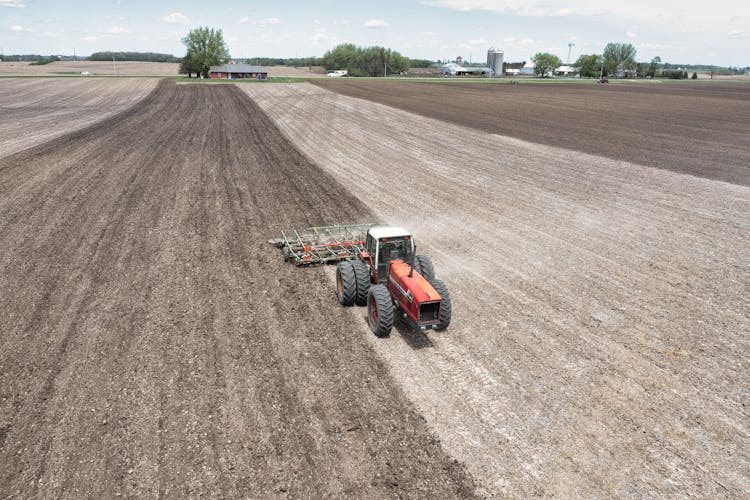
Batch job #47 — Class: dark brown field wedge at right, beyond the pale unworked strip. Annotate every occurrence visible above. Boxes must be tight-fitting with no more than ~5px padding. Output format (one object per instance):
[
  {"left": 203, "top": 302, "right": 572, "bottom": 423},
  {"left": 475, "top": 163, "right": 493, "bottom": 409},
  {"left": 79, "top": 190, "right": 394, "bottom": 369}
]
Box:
[{"left": 316, "top": 80, "right": 750, "bottom": 186}]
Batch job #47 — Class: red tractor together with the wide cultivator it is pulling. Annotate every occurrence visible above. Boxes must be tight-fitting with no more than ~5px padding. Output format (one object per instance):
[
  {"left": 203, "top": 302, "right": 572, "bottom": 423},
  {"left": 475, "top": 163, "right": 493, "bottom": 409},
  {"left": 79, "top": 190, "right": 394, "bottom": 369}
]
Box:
[{"left": 268, "top": 224, "right": 451, "bottom": 337}]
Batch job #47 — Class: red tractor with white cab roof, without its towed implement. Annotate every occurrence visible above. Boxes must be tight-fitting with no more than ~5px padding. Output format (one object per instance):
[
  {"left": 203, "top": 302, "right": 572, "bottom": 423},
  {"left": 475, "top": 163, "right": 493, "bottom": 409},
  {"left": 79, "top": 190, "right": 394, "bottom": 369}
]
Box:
[{"left": 336, "top": 226, "right": 451, "bottom": 337}]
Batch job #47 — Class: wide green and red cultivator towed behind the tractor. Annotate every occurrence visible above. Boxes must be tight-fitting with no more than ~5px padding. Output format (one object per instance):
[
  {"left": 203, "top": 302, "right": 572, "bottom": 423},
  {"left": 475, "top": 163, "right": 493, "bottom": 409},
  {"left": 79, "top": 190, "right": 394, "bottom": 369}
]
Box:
[{"left": 268, "top": 224, "right": 373, "bottom": 266}]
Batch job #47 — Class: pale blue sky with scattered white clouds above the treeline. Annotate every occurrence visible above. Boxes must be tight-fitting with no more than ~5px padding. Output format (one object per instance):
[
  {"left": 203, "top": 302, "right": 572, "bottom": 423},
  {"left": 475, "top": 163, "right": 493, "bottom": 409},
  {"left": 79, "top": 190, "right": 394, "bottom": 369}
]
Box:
[{"left": 0, "top": 0, "right": 750, "bottom": 67}]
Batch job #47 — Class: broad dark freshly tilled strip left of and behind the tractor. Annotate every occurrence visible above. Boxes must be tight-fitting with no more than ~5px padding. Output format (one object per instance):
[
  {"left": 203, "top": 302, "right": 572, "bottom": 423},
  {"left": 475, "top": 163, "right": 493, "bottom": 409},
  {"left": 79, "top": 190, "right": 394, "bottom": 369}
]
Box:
[{"left": 0, "top": 82, "right": 473, "bottom": 498}]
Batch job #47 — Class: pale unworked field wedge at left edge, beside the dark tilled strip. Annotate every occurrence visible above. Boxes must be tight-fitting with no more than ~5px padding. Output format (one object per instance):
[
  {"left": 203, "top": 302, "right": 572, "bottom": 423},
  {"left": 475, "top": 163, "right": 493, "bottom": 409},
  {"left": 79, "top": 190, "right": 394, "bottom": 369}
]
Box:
[{"left": 0, "top": 78, "right": 158, "bottom": 157}]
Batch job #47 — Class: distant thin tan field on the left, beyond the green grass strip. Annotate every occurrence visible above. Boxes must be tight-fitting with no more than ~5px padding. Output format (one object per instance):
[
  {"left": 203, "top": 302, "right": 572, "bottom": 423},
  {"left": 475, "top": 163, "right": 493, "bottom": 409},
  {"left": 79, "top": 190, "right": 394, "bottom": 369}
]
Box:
[{"left": 0, "top": 61, "right": 180, "bottom": 77}]
